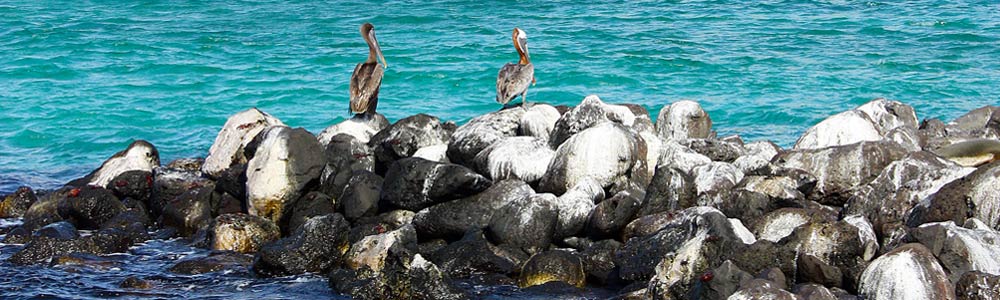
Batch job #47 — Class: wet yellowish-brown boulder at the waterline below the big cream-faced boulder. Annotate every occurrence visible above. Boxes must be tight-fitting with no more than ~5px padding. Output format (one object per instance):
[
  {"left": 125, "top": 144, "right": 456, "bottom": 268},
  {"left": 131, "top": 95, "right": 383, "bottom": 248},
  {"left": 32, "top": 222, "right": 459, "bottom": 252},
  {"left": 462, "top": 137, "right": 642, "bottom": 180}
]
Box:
[{"left": 208, "top": 214, "right": 281, "bottom": 253}]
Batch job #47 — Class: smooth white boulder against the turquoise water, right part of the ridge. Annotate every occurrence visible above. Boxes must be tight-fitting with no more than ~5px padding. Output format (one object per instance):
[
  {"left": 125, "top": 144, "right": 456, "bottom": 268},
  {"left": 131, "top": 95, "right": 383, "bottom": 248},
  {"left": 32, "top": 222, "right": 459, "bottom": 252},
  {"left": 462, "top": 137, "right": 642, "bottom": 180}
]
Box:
[{"left": 794, "top": 110, "right": 882, "bottom": 149}]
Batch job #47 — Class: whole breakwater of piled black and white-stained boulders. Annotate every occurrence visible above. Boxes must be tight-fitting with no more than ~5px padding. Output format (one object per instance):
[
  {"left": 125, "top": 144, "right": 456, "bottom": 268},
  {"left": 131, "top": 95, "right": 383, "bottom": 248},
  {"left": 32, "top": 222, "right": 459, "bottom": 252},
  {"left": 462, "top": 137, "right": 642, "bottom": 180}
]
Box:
[{"left": 0, "top": 96, "right": 1000, "bottom": 299}]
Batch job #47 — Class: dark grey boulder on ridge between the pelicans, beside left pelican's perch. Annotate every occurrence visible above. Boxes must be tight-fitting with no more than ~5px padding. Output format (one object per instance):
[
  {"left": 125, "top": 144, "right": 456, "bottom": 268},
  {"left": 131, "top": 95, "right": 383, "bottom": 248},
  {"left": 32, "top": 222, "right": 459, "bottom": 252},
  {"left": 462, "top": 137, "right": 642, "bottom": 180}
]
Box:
[{"left": 368, "top": 114, "right": 455, "bottom": 168}]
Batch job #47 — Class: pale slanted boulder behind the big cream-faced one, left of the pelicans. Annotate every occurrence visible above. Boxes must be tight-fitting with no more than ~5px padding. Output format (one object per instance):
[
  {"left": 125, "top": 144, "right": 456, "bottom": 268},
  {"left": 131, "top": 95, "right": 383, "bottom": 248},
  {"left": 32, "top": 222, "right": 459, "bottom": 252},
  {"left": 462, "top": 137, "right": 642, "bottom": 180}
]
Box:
[{"left": 201, "top": 108, "right": 284, "bottom": 176}]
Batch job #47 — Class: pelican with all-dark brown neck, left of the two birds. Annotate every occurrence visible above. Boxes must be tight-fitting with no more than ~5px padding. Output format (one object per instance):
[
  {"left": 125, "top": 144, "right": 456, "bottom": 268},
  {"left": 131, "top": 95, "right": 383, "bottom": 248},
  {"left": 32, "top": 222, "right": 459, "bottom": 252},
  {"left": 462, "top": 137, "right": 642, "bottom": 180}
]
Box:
[{"left": 351, "top": 23, "right": 389, "bottom": 116}]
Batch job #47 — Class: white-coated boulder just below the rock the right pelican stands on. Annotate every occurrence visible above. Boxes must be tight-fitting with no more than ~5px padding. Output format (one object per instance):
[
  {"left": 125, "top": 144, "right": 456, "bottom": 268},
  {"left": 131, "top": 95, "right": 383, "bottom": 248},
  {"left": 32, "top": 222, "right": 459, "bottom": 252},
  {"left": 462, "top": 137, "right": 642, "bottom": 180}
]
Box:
[{"left": 475, "top": 136, "right": 556, "bottom": 182}]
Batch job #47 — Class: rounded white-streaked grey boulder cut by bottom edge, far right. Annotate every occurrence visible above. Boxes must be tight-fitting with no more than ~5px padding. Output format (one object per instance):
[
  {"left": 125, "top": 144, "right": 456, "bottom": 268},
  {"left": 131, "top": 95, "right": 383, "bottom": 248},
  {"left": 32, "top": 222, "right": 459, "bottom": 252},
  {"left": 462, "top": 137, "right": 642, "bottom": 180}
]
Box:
[{"left": 858, "top": 244, "right": 955, "bottom": 300}]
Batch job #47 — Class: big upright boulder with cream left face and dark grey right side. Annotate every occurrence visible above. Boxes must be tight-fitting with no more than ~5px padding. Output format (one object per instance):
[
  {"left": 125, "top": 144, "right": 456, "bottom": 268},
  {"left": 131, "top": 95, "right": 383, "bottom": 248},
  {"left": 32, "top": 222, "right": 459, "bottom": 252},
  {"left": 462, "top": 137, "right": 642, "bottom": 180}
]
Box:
[{"left": 246, "top": 126, "right": 326, "bottom": 223}]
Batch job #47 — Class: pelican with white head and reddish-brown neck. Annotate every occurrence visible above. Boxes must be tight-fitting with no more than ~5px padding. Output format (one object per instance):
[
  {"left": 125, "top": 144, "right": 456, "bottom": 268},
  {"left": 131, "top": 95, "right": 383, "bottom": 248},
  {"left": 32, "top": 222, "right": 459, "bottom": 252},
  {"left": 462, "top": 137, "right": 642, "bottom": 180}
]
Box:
[{"left": 497, "top": 27, "right": 535, "bottom": 107}]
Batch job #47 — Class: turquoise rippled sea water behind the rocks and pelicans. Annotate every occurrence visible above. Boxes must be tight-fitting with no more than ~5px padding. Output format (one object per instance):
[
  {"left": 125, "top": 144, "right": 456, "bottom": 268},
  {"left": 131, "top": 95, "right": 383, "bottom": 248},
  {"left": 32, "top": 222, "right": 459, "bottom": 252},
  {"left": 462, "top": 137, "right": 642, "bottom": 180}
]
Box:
[{"left": 0, "top": 0, "right": 1000, "bottom": 192}]
